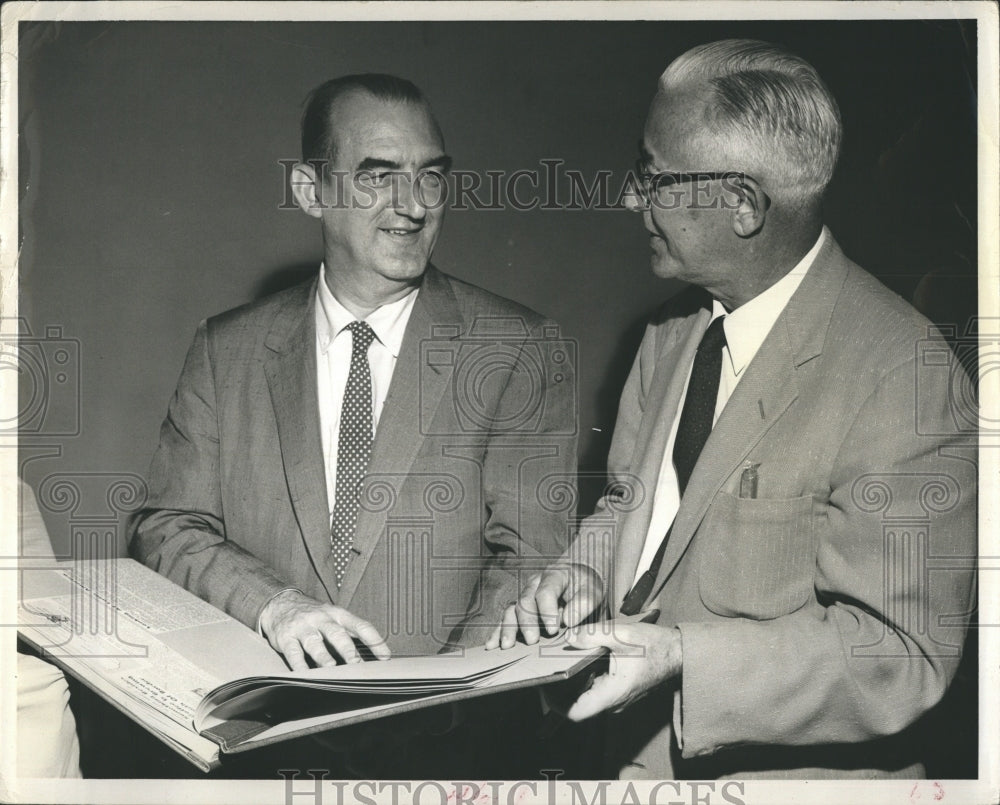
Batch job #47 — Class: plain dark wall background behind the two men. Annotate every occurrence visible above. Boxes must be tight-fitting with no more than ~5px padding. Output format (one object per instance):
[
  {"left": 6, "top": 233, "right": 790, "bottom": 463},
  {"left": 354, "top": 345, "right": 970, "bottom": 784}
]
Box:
[{"left": 18, "top": 21, "right": 977, "bottom": 776}]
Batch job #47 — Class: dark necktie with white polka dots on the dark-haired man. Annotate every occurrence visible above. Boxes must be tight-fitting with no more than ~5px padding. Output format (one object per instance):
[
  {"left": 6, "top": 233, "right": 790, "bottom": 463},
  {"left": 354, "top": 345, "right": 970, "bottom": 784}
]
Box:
[{"left": 330, "top": 321, "right": 375, "bottom": 587}]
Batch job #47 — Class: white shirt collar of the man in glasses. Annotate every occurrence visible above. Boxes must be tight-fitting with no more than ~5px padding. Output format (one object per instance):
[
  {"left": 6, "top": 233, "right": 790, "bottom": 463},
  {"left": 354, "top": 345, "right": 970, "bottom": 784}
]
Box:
[{"left": 712, "top": 227, "right": 826, "bottom": 377}]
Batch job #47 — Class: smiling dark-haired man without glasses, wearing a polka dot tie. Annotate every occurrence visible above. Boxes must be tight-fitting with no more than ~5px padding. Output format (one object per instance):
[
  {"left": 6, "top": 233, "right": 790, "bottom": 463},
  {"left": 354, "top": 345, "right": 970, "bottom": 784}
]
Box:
[{"left": 131, "top": 75, "right": 576, "bottom": 669}]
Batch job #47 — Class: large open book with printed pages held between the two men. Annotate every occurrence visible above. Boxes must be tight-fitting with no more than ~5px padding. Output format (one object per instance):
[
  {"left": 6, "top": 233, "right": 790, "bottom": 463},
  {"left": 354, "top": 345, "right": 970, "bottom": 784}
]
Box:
[{"left": 18, "top": 559, "right": 640, "bottom": 771}]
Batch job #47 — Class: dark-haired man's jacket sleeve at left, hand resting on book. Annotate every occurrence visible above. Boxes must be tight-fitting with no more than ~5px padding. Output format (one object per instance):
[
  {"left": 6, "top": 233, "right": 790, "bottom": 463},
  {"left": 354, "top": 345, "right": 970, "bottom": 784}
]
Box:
[{"left": 129, "top": 322, "right": 291, "bottom": 628}]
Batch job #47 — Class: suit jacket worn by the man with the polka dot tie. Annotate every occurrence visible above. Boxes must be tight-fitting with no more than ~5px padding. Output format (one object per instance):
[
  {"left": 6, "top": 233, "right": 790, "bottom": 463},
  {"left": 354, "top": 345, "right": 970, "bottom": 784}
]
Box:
[{"left": 130, "top": 267, "right": 576, "bottom": 655}]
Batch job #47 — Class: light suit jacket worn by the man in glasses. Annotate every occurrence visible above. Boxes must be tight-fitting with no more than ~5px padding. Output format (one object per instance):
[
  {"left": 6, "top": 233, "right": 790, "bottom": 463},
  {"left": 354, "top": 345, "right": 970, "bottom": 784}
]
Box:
[{"left": 569, "top": 233, "right": 976, "bottom": 778}]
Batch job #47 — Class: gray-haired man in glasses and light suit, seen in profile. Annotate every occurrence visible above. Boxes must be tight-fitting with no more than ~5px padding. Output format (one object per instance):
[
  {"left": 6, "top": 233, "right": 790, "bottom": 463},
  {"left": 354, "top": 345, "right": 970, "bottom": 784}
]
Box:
[{"left": 489, "top": 40, "right": 976, "bottom": 778}]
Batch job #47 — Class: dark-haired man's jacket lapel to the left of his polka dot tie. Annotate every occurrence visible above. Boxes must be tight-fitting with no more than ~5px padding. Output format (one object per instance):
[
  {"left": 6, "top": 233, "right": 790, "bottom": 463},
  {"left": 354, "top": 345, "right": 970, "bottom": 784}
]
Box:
[{"left": 264, "top": 281, "right": 338, "bottom": 601}]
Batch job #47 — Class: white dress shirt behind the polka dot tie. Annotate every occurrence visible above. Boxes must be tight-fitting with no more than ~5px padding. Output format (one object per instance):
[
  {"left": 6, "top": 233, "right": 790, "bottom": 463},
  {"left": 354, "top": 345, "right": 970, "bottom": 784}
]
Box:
[{"left": 316, "top": 265, "right": 417, "bottom": 517}]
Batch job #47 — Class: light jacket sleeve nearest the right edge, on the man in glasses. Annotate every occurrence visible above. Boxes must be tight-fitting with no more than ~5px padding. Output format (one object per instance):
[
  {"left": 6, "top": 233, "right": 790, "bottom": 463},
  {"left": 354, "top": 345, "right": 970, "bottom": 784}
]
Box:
[{"left": 675, "top": 358, "right": 976, "bottom": 758}]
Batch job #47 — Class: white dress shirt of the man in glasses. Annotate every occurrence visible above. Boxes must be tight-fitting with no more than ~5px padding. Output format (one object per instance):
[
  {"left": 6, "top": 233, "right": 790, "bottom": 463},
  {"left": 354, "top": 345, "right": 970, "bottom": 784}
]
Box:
[{"left": 632, "top": 227, "right": 826, "bottom": 584}]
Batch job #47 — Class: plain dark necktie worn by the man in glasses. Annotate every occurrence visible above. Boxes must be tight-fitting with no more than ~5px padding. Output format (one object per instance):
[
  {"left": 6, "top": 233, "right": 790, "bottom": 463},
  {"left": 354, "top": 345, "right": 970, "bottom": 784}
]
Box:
[{"left": 621, "top": 316, "right": 726, "bottom": 615}]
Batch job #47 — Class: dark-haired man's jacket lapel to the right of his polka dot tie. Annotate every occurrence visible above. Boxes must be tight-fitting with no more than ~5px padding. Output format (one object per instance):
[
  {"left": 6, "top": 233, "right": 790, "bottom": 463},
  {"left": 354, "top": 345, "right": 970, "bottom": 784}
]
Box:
[{"left": 340, "top": 266, "right": 464, "bottom": 606}]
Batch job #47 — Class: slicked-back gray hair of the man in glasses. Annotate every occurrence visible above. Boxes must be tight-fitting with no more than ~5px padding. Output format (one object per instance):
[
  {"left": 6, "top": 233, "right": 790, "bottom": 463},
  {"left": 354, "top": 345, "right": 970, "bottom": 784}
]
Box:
[{"left": 660, "top": 39, "right": 842, "bottom": 203}]
